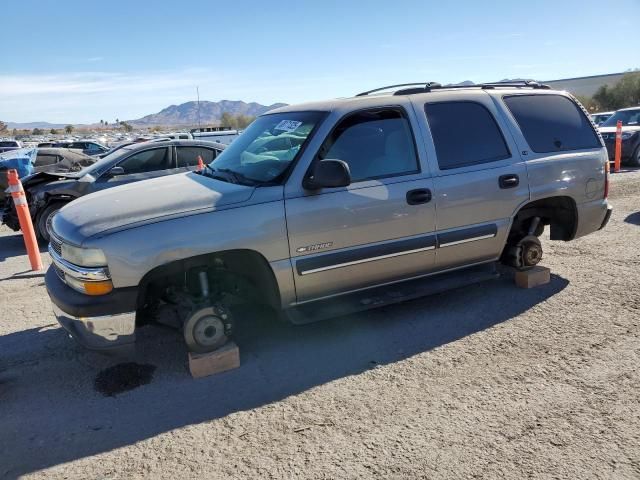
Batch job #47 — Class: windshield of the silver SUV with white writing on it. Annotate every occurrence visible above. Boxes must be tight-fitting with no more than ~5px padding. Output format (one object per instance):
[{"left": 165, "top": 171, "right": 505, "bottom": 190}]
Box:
[{"left": 205, "top": 112, "right": 325, "bottom": 184}]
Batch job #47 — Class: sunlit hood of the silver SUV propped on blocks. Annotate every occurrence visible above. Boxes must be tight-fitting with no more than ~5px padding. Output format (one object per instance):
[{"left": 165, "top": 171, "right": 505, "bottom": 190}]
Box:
[{"left": 53, "top": 172, "right": 255, "bottom": 245}]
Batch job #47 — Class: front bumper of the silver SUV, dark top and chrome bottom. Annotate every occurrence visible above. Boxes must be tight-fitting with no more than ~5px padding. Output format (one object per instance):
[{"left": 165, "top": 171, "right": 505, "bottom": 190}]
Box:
[{"left": 45, "top": 267, "right": 137, "bottom": 350}]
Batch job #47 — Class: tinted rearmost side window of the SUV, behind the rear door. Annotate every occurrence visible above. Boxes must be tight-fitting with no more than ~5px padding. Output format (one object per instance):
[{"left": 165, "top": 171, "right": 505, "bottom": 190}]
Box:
[{"left": 504, "top": 95, "right": 601, "bottom": 153}]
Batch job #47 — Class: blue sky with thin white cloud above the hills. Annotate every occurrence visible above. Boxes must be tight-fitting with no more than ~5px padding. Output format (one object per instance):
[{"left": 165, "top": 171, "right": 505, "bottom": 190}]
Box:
[{"left": 0, "top": 0, "right": 640, "bottom": 123}]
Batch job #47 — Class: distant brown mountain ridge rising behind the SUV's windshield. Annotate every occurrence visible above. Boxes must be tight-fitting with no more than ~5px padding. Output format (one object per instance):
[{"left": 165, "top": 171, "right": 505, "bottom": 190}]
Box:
[{"left": 127, "top": 100, "right": 286, "bottom": 127}]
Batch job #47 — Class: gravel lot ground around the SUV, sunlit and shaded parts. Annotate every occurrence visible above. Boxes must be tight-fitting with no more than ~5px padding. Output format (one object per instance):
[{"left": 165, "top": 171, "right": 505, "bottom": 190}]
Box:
[{"left": 0, "top": 171, "right": 640, "bottom": 479}]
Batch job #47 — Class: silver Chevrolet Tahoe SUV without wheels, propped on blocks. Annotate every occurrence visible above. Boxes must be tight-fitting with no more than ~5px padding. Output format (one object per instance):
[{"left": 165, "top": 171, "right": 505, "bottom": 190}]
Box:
[{"left": 46, "top": 83, "right": 611, "bottom": 352}]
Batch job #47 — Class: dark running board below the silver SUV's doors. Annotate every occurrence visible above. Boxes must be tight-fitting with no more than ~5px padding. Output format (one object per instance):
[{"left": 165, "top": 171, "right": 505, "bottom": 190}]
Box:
[{"left": 282, "top": 262, "right": 500, "bottom": 325}]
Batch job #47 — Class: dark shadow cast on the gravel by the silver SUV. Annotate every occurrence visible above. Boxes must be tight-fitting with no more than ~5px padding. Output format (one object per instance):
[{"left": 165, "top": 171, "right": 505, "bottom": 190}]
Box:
[{"left": 0, "top": 275, "right": 568, "bottom": 478}]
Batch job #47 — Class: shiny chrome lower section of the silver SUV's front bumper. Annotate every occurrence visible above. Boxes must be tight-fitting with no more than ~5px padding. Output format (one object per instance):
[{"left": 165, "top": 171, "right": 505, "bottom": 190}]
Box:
[{"left": 53, "top": 304, "right": 136, "bottom": 350}]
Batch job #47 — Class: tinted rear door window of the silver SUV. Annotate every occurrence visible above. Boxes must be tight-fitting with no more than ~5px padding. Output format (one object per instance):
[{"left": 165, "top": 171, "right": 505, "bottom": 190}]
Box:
[{"left": 424, "top": 101, "right": 511, "bottom": 170}]
